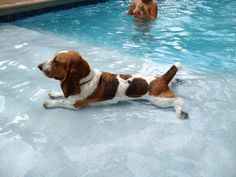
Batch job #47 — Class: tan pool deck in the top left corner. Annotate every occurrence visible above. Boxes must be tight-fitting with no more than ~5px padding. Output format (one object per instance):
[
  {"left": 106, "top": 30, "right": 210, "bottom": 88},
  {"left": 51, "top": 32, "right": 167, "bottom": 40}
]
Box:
[{"left": 0, "top": 0, "right": 86, "bottom": 16}]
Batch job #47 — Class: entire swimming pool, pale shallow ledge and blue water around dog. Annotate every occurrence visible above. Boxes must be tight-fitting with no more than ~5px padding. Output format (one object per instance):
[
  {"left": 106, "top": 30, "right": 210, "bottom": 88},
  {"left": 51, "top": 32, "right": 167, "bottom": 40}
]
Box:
[{"left": 0, "top": 0, "right": 236, "bottom": 177}]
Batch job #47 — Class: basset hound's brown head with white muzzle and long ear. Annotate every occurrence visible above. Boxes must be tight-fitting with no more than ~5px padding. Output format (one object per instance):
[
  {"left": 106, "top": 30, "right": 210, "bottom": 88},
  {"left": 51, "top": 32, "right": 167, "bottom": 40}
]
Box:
[{"left": 38, "top": 51, "right": 90, "bottom": 97}]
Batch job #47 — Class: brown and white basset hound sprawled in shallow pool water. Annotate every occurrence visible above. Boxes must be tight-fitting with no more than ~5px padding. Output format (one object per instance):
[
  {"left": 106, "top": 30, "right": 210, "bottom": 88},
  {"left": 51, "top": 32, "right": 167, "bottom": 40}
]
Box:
[{"left": 38, "top": 51, "right": 188, "bottom": 119}]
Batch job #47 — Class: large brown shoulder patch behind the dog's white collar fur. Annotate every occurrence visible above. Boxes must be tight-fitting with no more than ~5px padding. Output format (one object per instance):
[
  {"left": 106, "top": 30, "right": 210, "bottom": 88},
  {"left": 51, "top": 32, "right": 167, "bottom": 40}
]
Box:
[{"left": 75, "top": 72, "right": 119, "bottom": 107}]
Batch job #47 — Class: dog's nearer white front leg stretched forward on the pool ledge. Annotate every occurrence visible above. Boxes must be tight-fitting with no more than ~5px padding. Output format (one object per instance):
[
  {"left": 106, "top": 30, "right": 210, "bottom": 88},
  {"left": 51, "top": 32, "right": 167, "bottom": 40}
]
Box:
[{"left": 43, "top": 98, "right": 78, "bottom": 109}]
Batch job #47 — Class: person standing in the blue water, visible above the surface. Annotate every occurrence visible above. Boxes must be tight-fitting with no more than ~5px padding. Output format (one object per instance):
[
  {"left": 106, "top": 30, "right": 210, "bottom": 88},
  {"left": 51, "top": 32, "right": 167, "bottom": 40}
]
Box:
[{"left": 128, "top": 0, "right": 158, "bottom": 20}]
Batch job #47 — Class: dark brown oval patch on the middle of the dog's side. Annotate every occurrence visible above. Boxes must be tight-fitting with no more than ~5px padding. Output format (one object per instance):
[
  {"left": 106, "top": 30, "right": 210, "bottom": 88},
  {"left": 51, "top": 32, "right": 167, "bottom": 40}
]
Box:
[{"left": 125, "top": 78, "right": 149, "bottom": 98}]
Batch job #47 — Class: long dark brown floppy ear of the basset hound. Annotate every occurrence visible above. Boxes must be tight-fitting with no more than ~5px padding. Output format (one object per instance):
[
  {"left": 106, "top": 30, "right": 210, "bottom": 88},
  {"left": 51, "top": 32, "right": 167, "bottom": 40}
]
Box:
[{"left": 61, "top": 56, "right": 90, "bottom": 98}]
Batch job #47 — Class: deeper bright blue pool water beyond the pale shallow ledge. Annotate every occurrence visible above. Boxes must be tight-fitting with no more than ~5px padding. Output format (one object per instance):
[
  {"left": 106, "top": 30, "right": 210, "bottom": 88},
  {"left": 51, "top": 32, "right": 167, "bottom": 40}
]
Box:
[{"left": 16, "top": 0, "right": 236, "bottom": 73}]
